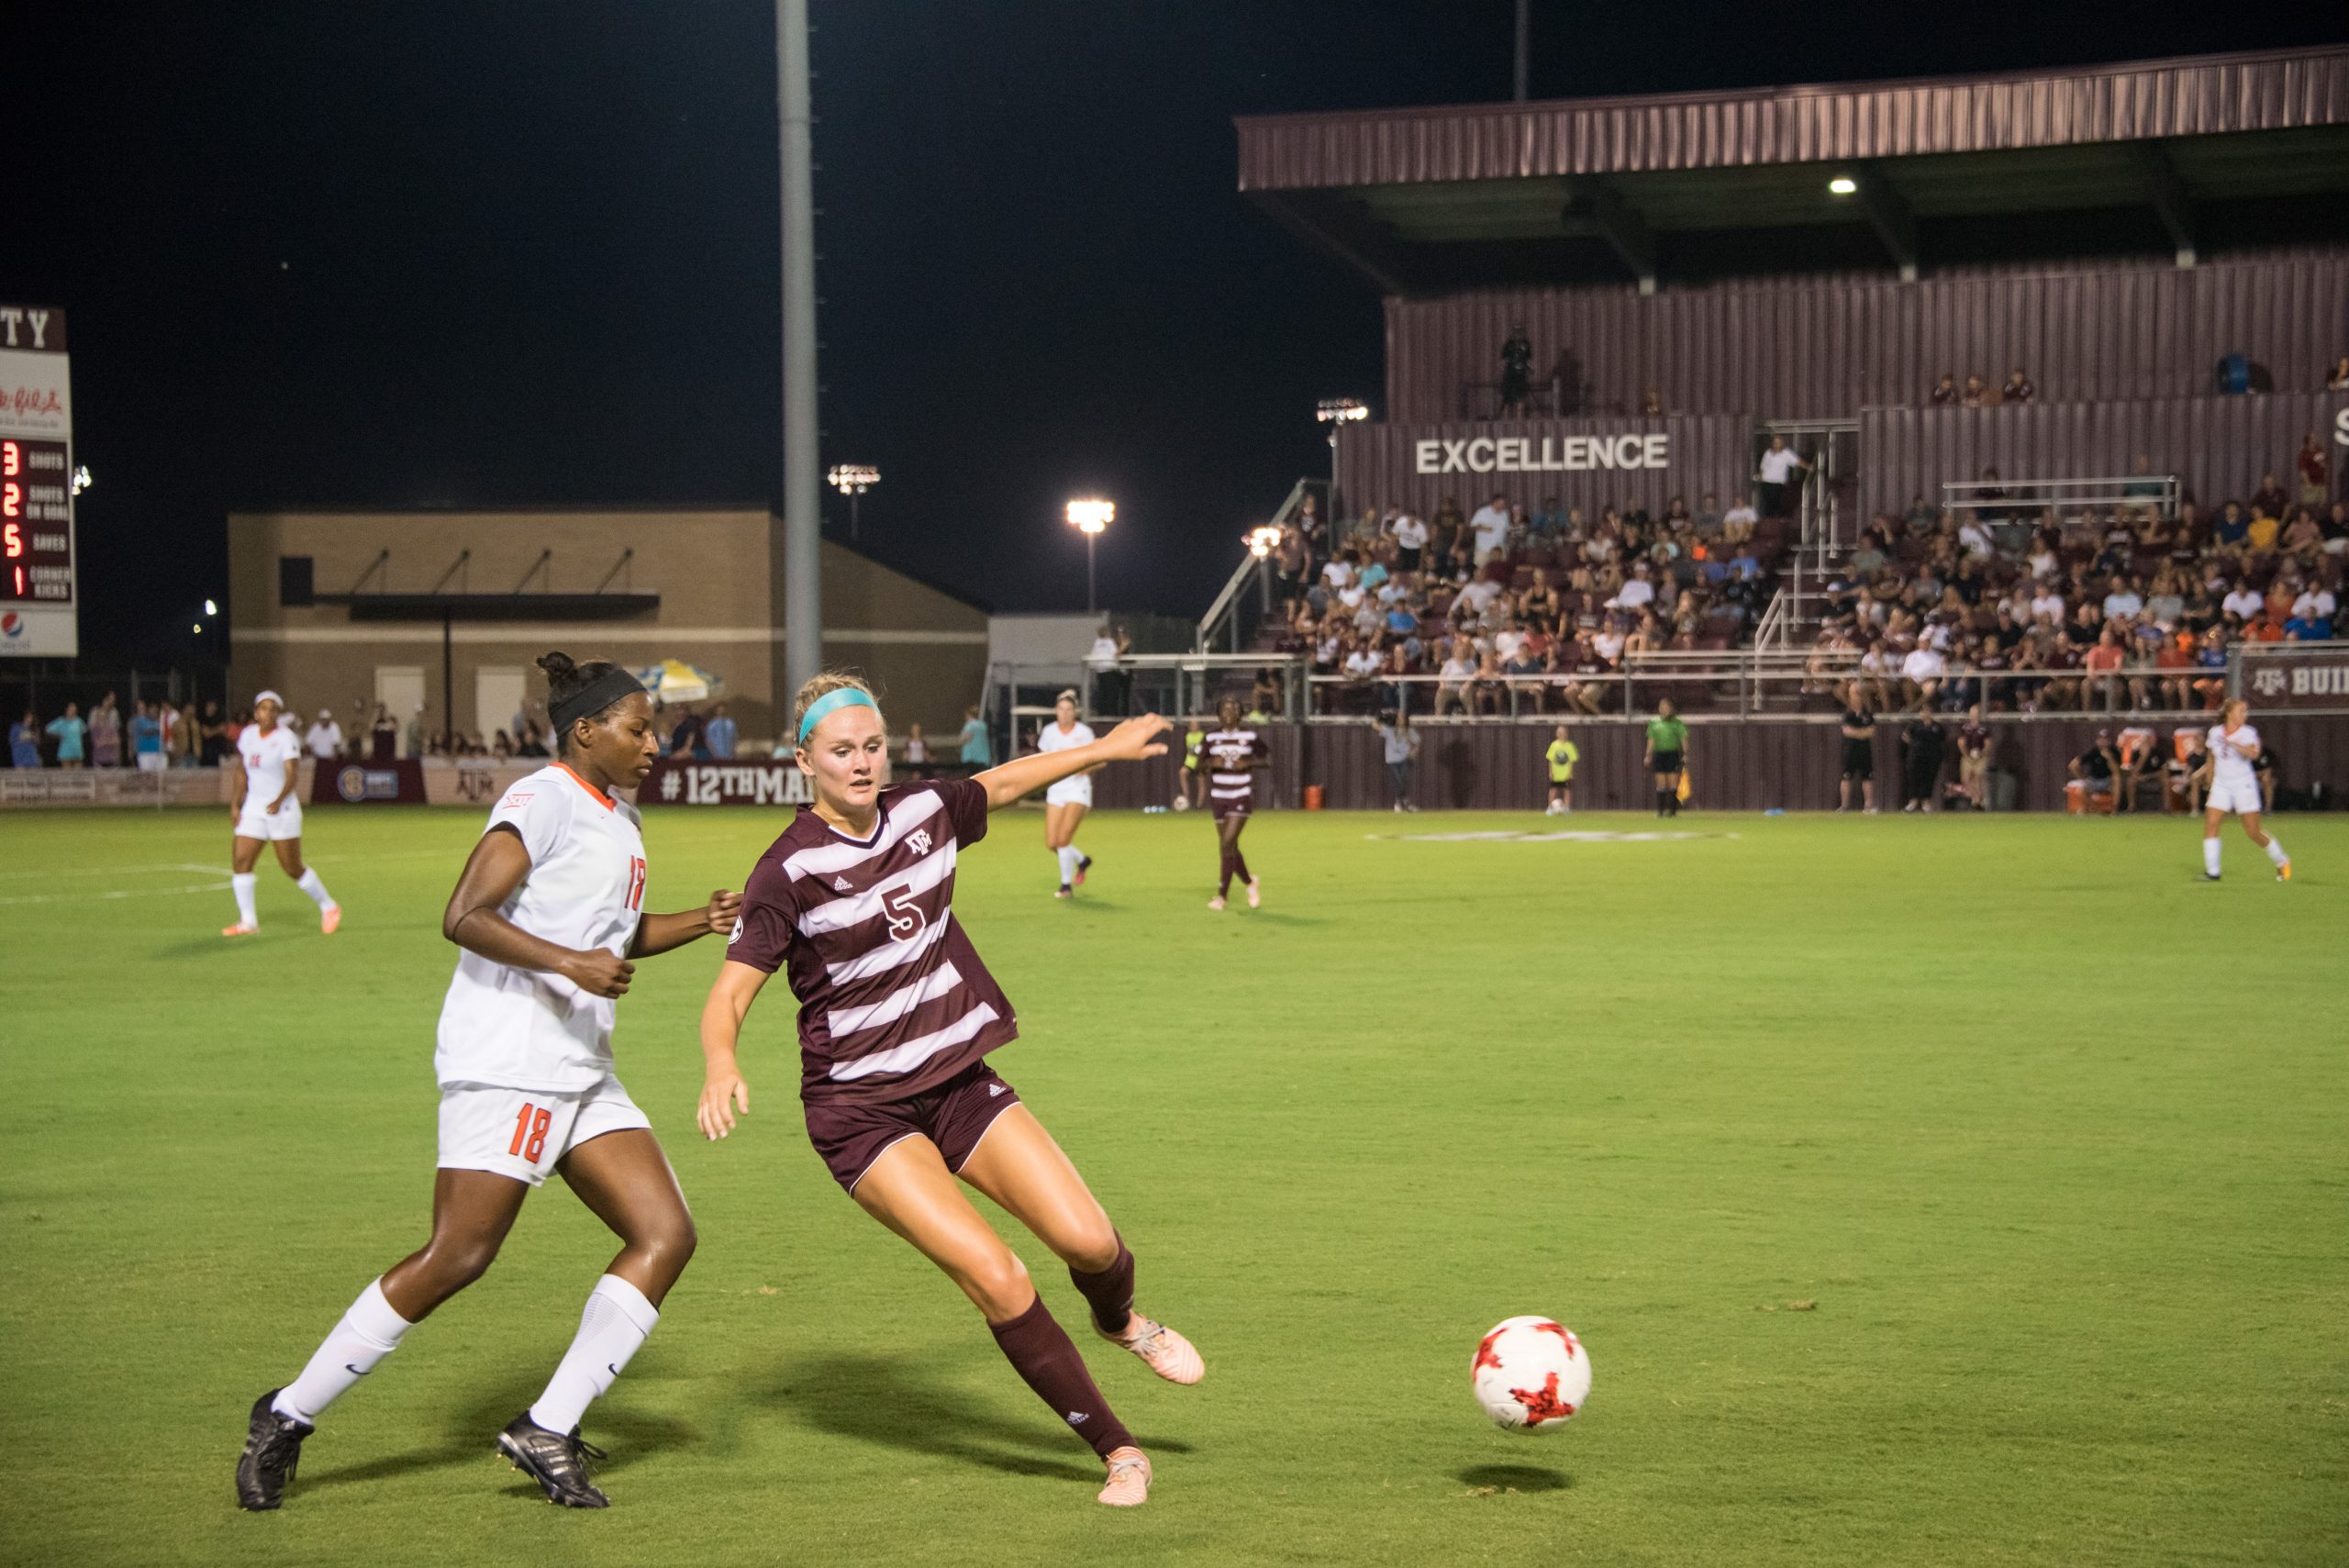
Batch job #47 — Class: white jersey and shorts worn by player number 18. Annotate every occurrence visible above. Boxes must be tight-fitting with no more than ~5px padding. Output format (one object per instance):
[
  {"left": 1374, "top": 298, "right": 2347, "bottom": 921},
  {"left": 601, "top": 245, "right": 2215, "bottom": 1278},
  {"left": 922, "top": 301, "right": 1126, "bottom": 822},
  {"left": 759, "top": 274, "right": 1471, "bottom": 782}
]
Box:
[{"left": 432, "top": 762, "right": 646, "bottom": 1092}]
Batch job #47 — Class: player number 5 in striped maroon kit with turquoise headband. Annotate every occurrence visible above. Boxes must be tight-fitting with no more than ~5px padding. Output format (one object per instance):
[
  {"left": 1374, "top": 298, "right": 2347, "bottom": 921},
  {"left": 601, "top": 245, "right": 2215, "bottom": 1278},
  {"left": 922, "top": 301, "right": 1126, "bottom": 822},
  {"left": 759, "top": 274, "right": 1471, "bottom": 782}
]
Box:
[{"left": 700, "top": 676, "right": 1205, "bottom": 1507}]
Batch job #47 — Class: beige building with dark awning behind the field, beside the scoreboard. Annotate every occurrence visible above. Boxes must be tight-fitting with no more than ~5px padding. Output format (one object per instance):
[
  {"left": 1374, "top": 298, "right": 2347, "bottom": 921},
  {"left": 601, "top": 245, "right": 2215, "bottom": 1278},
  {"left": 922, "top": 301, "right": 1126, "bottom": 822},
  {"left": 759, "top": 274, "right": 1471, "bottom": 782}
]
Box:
[{"left": 228, "top": 507, "right": 986, "bottom": 741}]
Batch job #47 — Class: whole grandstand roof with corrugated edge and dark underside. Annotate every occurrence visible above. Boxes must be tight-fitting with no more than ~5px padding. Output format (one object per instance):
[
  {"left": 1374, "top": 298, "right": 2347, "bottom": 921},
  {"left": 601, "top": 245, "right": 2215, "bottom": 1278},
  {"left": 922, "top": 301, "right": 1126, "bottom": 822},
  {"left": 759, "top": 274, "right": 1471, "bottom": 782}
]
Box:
[{"left": 1238, "top": 50, "right": 2349, "bottom": 294}]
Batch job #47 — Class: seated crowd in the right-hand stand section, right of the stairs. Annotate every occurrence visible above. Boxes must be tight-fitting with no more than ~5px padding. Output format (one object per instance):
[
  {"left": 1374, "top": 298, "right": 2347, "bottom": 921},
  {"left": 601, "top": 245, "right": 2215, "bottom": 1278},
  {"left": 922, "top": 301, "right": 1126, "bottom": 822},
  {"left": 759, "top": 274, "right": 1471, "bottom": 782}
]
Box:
[{"left": 1807, "top": 432, "right": 2349, "bottom": 711}]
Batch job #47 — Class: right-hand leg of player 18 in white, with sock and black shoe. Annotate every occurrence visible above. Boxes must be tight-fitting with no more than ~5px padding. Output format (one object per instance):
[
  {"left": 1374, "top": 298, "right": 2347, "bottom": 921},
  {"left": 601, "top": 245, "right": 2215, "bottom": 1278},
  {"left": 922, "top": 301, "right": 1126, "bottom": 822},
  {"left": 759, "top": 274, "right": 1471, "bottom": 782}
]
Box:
[{"left": 481, "top": 1127, "right": 696, "bottom": 1507}]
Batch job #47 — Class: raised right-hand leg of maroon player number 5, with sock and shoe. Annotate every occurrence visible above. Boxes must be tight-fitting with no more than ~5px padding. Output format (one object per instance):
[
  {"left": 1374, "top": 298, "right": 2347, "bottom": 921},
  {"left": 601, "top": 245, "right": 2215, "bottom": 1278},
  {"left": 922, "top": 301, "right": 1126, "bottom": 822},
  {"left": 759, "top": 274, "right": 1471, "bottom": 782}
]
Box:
[{"left": 961, "top": 1106, "right": 1208, "bottom": 1383}]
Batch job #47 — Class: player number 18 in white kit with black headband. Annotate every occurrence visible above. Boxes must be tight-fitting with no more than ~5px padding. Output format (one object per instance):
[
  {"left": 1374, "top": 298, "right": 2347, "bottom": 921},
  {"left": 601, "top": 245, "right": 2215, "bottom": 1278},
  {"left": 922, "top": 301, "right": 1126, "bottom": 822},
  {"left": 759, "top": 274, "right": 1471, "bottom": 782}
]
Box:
[{"left": 238, "top": 652, "right": 740, "bottom": 1509}]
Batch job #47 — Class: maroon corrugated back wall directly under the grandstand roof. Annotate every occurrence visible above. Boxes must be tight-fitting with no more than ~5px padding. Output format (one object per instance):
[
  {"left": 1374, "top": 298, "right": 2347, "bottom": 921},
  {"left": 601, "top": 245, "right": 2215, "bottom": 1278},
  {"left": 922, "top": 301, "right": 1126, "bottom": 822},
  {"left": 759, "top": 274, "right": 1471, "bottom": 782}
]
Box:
[{"left": 1386, "top": 251, "right": 2349, "bottom": 423}]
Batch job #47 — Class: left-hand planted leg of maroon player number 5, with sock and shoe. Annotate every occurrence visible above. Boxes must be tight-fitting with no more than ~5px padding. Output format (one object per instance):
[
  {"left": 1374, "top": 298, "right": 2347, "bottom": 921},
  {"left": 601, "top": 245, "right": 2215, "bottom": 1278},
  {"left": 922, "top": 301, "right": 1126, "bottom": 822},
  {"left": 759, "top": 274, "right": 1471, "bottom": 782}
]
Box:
[{"left": 852, "top": 1131, "right": 1149, "bottom": 1505}]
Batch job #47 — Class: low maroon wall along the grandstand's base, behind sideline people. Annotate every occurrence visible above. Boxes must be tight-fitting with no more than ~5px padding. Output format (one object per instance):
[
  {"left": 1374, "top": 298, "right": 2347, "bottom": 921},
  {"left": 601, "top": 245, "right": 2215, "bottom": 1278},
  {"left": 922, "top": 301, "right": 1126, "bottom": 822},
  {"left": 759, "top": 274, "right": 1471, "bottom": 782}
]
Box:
[{"left": 1095, "top": 714, "right": 2349, "bottom": 817}]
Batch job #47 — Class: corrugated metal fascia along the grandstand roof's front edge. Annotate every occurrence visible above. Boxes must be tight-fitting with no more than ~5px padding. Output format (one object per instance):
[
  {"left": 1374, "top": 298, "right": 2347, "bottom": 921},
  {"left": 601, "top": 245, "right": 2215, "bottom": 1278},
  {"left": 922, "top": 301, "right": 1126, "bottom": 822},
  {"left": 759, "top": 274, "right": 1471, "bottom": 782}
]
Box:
[{"left": 1238, "top": 50, "right": 2349, "bottom": 190}]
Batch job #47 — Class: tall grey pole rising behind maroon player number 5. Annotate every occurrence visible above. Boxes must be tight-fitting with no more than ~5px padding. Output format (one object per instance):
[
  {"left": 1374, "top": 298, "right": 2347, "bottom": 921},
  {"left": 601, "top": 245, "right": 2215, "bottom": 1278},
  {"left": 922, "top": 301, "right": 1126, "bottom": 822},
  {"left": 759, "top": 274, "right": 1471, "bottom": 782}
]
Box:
[{"left": 775, "top": 0, "right": 825, "bottom": 702}]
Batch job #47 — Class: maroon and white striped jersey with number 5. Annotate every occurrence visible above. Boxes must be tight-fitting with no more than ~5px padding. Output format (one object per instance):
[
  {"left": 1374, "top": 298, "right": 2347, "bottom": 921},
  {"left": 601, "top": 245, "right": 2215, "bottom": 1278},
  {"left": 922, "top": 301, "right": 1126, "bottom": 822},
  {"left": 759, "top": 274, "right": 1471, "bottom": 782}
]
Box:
[{"left": 726, "top": 779, "right": 1019, "bottom": 1101}]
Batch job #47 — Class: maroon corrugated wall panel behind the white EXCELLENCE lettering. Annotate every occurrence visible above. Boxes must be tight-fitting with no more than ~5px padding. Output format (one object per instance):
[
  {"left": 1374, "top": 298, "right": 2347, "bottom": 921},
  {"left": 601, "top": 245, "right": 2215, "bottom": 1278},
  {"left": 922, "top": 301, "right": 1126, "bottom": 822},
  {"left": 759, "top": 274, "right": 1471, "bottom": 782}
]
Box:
[{"left": 1337, "top": 413, "right": 1753, "bottom": 518}]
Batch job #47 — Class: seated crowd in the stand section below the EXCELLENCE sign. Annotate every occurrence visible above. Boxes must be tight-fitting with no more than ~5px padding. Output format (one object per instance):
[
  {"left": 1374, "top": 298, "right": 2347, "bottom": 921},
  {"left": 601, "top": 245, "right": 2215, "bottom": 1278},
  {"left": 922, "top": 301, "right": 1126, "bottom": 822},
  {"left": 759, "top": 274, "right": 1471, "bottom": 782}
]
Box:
[{"left": 1268, "top": 484, "right": 1790, "bottom": 716}]
